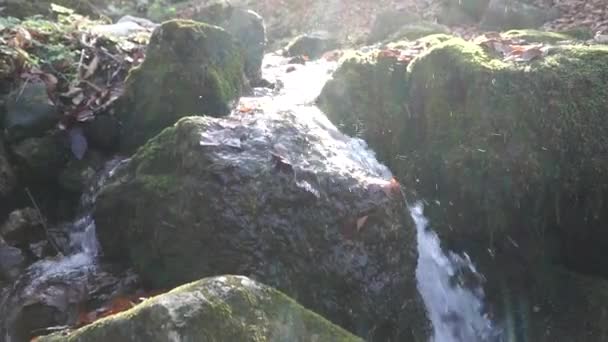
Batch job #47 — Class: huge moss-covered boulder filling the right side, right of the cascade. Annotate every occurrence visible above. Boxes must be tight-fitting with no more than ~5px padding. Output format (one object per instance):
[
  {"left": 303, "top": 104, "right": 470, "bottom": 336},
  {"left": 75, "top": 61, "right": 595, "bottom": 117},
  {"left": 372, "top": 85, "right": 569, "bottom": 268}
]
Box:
[{"left": 321, "top": 39, "right": 608, "bottom": 341}]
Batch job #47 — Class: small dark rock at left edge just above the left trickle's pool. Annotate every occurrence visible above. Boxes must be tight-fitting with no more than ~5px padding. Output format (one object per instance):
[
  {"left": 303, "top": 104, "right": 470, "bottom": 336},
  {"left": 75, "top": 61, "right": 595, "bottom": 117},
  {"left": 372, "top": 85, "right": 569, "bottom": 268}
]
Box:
[{"left": 0, "top": 208, "right": 45, "bottom": 247}]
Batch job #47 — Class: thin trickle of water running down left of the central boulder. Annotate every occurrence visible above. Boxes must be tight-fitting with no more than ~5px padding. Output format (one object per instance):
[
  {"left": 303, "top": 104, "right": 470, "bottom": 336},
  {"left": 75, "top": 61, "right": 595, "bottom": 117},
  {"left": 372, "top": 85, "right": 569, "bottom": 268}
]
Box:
[{"left": 0, "top": 159, "right": 129, "bottom": 342}]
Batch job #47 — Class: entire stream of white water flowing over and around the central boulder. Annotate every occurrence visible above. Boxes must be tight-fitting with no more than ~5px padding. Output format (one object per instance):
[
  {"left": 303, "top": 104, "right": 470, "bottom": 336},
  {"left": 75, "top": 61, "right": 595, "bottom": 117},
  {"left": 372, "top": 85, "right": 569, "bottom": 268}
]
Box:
[{"left": 0, "top": 54, "right": 500, "bottom": 342}]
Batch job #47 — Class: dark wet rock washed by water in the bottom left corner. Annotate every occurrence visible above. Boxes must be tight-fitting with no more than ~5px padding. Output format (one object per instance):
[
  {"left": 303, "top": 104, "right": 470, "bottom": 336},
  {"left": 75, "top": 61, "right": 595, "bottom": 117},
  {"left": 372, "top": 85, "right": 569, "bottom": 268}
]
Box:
[{"left": 0, "top": 253, "right": 134, "bottom": 342}]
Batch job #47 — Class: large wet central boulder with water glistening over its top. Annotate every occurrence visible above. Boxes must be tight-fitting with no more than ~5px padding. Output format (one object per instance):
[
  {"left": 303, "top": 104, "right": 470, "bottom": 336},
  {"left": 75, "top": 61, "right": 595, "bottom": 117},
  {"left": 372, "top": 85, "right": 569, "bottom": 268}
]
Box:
[{"left": 94, "top": 112, "right": 425, "bottom": 341}]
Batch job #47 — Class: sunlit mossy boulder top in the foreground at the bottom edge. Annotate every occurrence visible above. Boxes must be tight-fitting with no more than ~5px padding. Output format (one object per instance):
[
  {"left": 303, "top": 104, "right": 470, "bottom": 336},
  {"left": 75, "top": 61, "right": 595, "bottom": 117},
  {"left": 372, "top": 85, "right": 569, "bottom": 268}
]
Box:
[{"left": 38, "top": 276, "right": 363, "bottom": 342}]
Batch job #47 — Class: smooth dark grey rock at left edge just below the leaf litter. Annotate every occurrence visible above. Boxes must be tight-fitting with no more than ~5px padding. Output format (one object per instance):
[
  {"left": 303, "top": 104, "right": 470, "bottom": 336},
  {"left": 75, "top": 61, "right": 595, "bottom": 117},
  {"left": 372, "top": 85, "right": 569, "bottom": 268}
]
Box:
[{"left": 4, "top": 82, "right": 59, "bottom": 141}]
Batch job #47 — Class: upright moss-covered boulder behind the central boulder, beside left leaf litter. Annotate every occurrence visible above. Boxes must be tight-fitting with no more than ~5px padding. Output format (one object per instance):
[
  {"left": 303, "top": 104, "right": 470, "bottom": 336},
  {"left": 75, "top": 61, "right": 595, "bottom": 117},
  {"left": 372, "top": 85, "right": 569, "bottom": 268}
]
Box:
[{"left": 117, "top": 20, "right": 243, "bottom": 150}]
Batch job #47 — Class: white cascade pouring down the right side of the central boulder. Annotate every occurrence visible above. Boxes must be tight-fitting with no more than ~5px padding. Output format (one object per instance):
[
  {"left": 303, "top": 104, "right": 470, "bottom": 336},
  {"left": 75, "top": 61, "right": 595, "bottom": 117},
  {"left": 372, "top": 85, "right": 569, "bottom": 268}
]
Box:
[{"left": 410, "top": 203, "right": 500, "bottom": 342}]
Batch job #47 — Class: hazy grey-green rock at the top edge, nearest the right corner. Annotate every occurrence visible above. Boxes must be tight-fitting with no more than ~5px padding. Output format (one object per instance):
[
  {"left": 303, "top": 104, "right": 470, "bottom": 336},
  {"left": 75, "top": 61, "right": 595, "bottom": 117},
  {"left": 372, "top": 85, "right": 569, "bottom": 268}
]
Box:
[{"left": 480, "top": 0, "right": 559, "bottom": 30}]
